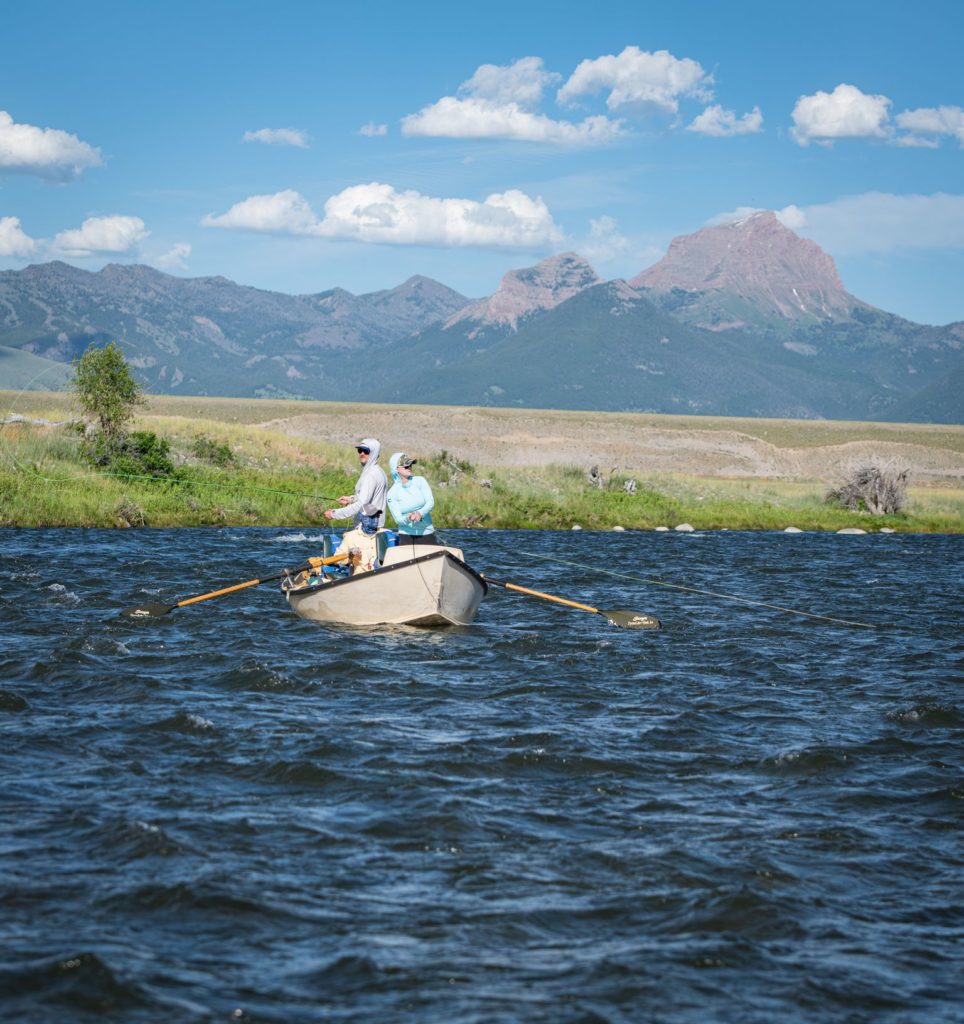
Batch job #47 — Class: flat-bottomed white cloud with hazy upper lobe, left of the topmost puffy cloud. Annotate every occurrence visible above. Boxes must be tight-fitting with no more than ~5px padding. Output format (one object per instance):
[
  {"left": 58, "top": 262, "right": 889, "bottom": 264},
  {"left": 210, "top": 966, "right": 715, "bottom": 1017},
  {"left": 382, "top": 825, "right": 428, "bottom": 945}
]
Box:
[{"left": 402, "top": 57, "right": 623, "bottom": 145}]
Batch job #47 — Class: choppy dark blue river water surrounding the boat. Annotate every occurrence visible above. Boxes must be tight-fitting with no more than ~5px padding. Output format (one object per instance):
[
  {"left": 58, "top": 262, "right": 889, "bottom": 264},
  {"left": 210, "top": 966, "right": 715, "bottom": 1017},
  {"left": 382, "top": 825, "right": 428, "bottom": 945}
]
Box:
[{"left": 0, "top": 529, "right": 964, "bottom": 1024}]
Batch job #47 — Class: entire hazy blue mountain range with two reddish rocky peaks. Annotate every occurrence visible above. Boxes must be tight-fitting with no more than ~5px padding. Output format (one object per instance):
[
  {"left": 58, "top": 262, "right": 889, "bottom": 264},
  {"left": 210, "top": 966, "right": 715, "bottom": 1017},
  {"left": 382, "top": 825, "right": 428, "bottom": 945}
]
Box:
[{"left": 0, "top": 212, "right": 964, "bottom": 423}]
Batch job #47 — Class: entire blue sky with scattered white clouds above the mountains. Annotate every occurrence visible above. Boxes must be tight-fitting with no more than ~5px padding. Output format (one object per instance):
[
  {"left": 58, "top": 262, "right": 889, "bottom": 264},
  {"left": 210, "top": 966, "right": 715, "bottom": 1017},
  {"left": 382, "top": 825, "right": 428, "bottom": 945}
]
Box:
[{"left": 0, "top": 0, "right": 964, "bottom": 324}]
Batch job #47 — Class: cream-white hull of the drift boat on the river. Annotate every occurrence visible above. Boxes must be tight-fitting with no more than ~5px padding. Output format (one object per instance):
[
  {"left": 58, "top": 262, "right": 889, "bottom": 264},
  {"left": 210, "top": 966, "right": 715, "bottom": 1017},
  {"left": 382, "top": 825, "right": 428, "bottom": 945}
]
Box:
[{"left": 286, "top": 545, "right": 488, "bottom": 626}]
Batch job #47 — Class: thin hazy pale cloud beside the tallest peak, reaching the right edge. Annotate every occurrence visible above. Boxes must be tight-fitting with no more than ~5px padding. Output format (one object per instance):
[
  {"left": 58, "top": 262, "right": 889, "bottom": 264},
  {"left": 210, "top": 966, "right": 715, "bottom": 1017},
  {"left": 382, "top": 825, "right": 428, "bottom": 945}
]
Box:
[{"left": 709, "top": 191, "right": 964, "bottom": 256}]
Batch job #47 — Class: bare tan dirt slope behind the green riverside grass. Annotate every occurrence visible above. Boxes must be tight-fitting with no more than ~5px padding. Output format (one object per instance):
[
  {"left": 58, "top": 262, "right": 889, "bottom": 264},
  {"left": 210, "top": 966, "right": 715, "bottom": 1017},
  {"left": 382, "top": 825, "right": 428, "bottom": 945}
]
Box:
[{"left": 261, "top": 406, "right": 964, "bottom": 484}]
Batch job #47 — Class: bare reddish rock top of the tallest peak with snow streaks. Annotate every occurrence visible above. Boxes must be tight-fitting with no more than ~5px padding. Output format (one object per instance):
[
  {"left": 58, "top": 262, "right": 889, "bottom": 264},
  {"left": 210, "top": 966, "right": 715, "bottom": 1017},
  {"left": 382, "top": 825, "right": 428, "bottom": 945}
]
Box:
[{"left": 630, "top": 210, "right": 863, "bottom": 330}]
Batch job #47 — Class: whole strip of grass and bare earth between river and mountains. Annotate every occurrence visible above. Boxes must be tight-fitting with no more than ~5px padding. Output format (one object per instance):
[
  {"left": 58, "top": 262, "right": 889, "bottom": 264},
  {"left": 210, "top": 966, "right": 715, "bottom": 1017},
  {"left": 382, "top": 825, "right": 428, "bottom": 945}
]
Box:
[{"left": 0, "top": 391, "right": 964, "bottom": 534}]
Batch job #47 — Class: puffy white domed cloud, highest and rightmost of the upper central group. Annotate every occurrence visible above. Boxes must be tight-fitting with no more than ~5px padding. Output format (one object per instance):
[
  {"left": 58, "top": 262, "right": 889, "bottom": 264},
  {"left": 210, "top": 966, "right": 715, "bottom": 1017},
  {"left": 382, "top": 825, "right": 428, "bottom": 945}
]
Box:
[{"left": 556, "top": 46, "right": 713, "bottom": 114}]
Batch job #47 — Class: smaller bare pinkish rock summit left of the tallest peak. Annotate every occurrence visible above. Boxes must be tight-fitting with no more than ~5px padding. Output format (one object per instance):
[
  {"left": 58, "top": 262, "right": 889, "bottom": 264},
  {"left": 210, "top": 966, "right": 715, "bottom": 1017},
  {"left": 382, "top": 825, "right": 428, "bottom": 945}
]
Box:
[{"left": 446, "top": 253, "right": 602, "bottom": 331}]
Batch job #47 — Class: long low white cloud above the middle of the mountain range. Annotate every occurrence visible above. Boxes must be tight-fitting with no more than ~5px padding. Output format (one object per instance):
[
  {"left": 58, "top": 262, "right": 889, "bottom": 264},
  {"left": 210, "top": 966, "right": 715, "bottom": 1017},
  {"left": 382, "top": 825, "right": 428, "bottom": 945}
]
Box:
[{"left": 202, "top": 182, "right": 562, "bottom": 248}]
